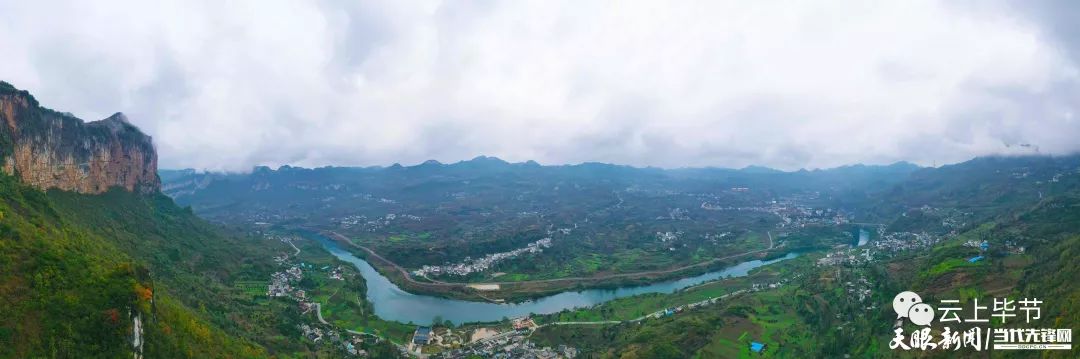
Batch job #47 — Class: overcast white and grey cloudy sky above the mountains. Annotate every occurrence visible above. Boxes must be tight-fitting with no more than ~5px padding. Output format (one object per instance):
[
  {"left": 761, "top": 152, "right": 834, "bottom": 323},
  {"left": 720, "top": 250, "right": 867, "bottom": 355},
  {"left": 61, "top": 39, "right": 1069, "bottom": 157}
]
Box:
[{"left": 0, "top": 0, "right": 1080, "bottom": 171}]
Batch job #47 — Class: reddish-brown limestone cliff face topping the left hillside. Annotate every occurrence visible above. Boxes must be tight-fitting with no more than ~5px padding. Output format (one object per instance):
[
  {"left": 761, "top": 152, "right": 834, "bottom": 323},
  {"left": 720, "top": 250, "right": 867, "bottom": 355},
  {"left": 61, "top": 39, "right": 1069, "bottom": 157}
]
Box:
[{"left": 0, "top": 81, "right": 161, "bottom": 194}]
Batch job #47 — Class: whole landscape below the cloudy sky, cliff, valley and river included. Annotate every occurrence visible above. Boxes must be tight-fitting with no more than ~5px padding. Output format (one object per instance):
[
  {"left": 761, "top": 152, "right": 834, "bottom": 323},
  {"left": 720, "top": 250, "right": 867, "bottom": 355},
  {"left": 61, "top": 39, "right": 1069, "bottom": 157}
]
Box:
[{"left": 0, "top": 83, "right": 1080, "bottom": 358}]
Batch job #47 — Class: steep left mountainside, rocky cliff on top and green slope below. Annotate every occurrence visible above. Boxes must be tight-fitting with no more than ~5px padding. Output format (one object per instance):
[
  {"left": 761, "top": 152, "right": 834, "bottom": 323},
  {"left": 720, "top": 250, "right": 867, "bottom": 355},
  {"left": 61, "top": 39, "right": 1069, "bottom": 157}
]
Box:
[{"left": 0, "top": 82, "right": 309, "bottom": 358}]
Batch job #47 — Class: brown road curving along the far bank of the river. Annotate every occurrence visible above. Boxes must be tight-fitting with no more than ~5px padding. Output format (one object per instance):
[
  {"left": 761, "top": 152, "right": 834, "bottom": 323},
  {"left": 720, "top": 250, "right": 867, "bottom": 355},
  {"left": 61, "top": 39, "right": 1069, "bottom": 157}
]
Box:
[{"left": 323, "top": 230, "right": 775, "bottom": 287}]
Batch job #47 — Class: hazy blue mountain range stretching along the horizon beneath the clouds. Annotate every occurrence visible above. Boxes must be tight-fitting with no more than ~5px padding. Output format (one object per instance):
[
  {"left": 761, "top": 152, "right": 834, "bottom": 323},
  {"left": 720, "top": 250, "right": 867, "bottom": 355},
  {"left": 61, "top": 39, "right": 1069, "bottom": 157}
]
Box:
[{"left": 162, "top": 152, "right": 1080, "bottom": 231}]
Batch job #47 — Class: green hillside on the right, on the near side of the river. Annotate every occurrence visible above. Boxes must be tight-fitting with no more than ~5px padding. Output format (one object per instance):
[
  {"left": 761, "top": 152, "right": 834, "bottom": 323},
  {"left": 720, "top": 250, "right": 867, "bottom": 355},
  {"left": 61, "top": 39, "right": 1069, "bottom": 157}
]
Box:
[{"left": 532, "top": 156, "right": 1080, "bottom": 358}]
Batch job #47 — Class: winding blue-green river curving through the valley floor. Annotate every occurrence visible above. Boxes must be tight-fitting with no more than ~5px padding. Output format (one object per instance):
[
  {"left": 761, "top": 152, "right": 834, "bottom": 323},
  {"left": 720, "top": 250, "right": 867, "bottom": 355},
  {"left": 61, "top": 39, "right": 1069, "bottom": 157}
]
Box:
[{"left": 310, "top": 234, "right": 798, "bottom": 323}]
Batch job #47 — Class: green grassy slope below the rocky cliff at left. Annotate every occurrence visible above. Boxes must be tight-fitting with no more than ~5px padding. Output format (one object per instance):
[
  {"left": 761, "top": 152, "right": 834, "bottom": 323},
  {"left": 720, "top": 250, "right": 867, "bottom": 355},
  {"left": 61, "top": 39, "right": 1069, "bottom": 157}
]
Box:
[{"left": 0, "top": 176, "right": 293, "bottom": 358}]
